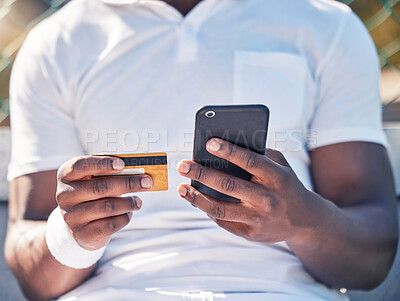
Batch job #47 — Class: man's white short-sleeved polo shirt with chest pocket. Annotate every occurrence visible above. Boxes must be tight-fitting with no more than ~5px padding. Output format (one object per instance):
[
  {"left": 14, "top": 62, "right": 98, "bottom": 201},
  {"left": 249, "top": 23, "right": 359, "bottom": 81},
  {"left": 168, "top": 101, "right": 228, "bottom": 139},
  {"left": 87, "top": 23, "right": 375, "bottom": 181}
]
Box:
[{"left": 8, "top": 0, "right": 385, "bottom": 301}]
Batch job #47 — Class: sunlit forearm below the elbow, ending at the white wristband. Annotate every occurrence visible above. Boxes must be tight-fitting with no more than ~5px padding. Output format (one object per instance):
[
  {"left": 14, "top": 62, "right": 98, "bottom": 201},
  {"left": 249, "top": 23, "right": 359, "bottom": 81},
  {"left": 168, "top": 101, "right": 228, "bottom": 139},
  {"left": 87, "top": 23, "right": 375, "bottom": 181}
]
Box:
[{"left": 5, "top": 220, "right": 95, "bottom": 300}]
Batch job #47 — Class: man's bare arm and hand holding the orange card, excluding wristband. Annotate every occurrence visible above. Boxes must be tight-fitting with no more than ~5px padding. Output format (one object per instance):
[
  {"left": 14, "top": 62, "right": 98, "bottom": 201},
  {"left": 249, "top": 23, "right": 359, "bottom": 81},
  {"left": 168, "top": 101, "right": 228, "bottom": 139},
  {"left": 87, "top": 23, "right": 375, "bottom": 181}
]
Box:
[{"left": 4, "top": 156, "right": 152, "bottom": 300}]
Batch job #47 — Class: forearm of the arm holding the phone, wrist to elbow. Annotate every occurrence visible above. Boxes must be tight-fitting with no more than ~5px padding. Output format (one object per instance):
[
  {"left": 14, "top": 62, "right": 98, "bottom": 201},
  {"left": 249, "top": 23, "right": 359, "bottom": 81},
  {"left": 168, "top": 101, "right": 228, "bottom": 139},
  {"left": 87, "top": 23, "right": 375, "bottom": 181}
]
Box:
[{"left": 287, "top": 192, "right": 398, "bottom": 289}]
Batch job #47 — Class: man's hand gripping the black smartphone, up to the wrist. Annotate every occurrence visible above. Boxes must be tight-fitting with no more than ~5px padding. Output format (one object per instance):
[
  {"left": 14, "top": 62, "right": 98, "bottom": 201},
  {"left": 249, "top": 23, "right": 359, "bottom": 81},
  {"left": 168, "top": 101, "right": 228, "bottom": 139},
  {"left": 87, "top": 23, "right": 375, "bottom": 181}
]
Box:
[{"left": 178, "top": 138, "right": 318, "bottom": 243}]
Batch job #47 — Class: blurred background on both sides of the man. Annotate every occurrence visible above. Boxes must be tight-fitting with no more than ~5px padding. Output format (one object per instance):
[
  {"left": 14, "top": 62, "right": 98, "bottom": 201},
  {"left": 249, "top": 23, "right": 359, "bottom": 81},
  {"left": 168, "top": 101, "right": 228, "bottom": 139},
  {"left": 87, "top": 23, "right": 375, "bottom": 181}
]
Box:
[{"left": 0, "top": 0, "right": 400, "bottom": 301}]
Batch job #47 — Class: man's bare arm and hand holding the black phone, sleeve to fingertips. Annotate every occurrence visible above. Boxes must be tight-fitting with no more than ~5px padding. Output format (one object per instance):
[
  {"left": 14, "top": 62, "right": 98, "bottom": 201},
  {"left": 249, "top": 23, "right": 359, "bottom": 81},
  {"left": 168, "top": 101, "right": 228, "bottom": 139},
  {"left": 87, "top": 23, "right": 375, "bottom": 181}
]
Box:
[{"left": 178, "top": 139, "right": 398, "bottom": 289}]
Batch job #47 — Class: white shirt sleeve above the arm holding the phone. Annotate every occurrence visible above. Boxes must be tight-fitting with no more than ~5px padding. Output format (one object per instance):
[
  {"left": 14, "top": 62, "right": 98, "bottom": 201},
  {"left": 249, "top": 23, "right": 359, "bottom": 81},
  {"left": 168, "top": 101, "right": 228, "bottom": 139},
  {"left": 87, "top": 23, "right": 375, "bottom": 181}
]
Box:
[{"left": 308, "top": 12, "right": 387, "bottom": 149}]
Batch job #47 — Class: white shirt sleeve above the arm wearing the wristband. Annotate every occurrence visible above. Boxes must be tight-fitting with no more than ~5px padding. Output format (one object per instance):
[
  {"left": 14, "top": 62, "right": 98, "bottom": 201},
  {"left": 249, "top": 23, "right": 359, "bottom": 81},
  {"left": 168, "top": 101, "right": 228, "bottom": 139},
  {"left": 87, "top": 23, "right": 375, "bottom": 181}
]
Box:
[{"left": 8, "top": 24, "right": 84, "bottom": 181}]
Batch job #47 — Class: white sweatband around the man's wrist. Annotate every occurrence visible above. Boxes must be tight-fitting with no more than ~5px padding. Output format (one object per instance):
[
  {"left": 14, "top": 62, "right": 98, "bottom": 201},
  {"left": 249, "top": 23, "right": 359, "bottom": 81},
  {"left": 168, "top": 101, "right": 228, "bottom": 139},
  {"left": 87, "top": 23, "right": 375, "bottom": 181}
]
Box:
[{"left": 46, "top": 206, "right": 106, "bottom": 269}]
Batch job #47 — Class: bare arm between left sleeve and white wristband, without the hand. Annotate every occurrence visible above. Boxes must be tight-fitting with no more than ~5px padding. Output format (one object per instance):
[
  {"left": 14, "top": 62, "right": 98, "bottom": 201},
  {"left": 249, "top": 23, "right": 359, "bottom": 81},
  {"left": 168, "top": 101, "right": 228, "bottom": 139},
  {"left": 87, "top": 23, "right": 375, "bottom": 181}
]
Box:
[{"left": 4, "top": 170, "right": 95, "bottom": 300}]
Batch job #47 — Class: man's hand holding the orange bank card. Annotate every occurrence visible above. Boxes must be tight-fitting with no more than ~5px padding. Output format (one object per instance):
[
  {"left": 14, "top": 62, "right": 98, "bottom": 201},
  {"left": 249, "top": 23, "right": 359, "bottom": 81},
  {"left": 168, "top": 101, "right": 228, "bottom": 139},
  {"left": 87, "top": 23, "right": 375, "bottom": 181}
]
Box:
[{"left": 56, "top": 156, "right": 153, "bottom": 250}]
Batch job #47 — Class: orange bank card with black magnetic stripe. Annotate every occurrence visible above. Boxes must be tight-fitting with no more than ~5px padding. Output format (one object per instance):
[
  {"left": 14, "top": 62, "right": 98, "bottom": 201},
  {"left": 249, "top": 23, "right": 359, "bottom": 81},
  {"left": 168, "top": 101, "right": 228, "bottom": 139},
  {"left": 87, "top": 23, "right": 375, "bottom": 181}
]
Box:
[{"left": 94, "top": 153, "right": 168, "bottom": 191}]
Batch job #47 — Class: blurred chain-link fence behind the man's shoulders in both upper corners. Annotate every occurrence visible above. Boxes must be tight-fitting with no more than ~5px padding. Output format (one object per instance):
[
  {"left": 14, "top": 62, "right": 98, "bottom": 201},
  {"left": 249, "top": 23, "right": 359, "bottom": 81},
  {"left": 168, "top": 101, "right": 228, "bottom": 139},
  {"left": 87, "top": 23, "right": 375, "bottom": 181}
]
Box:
[{"left": 0, "top": 0, "right": 400, "bottom": 126}]
